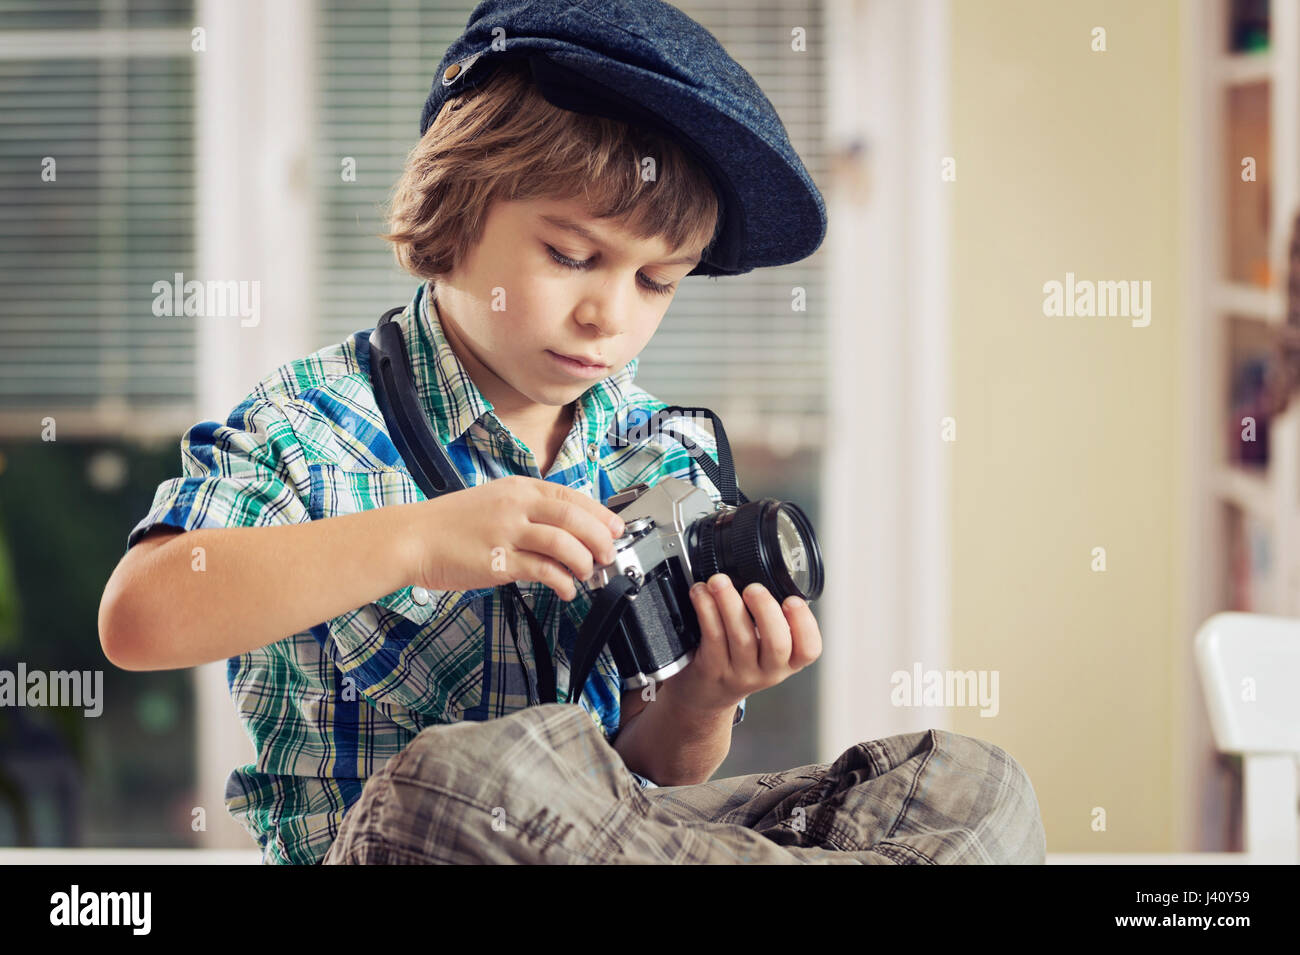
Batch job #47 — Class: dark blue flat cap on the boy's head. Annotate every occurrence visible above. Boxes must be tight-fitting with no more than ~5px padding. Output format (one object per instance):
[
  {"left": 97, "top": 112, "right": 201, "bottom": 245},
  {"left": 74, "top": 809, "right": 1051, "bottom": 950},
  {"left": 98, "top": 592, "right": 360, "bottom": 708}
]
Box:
[{"left": 420, "top": 0, "right": 826, "bottom": 275}]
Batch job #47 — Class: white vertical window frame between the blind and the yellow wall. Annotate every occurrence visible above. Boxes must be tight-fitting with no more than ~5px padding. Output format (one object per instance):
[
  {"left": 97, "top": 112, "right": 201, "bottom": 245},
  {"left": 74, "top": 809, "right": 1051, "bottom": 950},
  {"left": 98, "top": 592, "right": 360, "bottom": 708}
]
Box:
[{"left": 816, "top": 0, "right": 956, "bottom": 760}]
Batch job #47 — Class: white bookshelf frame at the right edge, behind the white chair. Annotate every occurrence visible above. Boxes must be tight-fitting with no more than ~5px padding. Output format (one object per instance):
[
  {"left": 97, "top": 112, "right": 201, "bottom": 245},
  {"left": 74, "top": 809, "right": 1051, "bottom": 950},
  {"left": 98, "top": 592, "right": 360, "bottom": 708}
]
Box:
[{"left": 1175, "top": 0, "right": 1300, "bottom": 847}]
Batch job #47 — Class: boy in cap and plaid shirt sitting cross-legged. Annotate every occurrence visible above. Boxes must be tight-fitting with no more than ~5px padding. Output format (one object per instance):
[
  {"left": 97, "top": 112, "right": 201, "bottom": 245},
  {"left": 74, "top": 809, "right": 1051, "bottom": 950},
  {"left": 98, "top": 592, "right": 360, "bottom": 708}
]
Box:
[{"left": 100, "top": 0, "right": 1043, "bottom": 863}]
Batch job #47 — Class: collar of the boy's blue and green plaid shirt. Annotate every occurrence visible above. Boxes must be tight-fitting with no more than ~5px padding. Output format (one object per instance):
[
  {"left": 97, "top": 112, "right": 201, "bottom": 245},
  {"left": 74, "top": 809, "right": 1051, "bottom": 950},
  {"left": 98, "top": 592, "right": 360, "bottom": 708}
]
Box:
[{"left": 394, "top": 282, "right": 638, "bottom": 446}]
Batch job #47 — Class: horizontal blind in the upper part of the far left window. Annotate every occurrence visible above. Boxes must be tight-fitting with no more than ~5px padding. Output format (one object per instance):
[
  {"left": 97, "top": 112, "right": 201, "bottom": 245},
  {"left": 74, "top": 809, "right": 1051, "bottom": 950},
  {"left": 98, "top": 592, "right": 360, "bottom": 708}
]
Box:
[{"left": 0, "top": 0, "right": 196, "bottom": 434}]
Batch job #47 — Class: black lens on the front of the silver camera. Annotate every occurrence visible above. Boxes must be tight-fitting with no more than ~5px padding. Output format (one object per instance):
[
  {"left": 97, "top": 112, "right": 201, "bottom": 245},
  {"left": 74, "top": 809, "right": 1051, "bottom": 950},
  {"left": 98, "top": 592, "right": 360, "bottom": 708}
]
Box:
[{"left": 685, "top": 498, "right": 823, "bottom": 602}]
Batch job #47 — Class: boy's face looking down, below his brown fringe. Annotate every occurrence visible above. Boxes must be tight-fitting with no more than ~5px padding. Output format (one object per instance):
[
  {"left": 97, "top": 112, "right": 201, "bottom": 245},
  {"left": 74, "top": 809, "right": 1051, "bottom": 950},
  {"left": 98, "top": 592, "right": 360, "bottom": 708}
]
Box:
[{"left": 436, "top": 199, "right": 702, "bottom": 417}]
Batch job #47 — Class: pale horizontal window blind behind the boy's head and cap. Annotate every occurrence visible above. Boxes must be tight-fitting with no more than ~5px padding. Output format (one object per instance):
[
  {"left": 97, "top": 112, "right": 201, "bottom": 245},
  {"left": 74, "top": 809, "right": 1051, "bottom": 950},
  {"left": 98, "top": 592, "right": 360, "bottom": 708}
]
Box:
[{"left": 313, "top": 0, "right": 828, "bottom": 447}]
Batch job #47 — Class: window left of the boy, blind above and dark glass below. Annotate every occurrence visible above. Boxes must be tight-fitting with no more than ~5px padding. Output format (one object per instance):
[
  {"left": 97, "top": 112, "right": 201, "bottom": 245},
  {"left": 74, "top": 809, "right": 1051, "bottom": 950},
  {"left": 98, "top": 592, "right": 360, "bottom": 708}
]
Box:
[{"left": 0, "top": 0, "right": 200, "bottom": 847}]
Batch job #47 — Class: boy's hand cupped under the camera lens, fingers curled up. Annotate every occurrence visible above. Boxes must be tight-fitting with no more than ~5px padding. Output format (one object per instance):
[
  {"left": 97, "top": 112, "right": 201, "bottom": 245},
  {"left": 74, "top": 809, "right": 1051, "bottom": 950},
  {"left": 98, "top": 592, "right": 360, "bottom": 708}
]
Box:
[{"left": 672, "top": 573, "right": 822, "bottom": 711}]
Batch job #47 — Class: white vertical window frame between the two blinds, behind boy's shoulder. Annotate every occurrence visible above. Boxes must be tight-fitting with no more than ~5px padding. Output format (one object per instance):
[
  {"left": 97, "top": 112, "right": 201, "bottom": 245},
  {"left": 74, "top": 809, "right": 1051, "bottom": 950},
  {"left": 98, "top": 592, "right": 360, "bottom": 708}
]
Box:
[{"left": 194, "top": 0, "right": 317, "bottom": 848}]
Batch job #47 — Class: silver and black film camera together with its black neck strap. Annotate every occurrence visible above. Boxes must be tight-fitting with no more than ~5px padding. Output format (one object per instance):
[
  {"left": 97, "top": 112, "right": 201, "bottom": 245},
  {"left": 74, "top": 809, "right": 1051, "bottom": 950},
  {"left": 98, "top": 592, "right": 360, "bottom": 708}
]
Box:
[{"left": 358, "top": 305, "right": 823, "bottom": 703}]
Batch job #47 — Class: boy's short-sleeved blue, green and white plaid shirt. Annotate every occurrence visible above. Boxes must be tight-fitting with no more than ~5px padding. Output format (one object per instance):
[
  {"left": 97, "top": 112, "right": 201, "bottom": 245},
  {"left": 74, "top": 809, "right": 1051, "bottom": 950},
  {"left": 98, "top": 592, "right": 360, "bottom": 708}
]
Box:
[{"left": 126, "top": 278, "right": 745, "bottom": 863}]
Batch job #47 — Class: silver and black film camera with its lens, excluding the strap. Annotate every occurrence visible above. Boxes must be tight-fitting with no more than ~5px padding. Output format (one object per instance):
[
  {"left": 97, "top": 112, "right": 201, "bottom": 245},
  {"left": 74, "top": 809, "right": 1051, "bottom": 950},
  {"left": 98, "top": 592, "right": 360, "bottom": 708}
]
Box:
[{"left": 586, "top": 478, "right": 822, "bottom": 690}]
